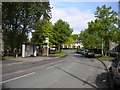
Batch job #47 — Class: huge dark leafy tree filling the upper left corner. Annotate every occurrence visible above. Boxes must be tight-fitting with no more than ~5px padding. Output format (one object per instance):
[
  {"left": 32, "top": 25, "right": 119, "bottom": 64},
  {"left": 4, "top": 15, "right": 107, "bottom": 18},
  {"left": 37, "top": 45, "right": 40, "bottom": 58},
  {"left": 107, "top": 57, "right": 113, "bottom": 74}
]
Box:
[{"left": 2, "top": 2, "right": 51, "bottom": 52}]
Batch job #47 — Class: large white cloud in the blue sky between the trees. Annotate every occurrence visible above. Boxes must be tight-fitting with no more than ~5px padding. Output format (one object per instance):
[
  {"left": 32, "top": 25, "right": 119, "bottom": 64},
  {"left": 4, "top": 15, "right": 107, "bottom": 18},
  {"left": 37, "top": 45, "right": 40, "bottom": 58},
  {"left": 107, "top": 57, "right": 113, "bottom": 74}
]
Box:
[{"left": 51, "top": 7, "right": 95, "bottom": 34}]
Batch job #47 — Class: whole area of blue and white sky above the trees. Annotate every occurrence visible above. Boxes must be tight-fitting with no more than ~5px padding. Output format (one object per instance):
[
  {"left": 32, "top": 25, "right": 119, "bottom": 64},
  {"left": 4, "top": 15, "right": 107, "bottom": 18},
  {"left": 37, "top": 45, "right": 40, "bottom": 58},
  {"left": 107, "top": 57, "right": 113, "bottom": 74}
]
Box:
[{"left": 50, "top": 0, "right": 118, "bottom": 34}]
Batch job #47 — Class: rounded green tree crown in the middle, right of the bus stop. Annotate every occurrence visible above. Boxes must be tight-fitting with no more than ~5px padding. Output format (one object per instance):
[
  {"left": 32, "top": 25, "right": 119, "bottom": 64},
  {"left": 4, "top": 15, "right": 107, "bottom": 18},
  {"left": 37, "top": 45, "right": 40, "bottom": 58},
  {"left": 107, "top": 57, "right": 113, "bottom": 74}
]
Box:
[{"left": 53, "top": 19, "right": 73, "bottom": 51}]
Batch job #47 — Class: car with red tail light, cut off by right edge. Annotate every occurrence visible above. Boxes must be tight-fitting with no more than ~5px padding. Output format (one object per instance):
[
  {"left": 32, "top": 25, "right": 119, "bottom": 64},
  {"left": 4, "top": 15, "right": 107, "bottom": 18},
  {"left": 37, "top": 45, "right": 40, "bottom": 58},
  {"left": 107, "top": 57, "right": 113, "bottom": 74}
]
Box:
[{"left": 109, "top": 56, "right": 120, "bottom": 86}]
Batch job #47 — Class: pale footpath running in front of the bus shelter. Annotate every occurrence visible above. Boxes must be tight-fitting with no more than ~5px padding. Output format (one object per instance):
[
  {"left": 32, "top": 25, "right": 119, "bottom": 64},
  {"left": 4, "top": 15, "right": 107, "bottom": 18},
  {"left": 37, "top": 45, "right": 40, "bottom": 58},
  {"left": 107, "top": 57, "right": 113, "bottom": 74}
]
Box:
[{"left": 0, "top": 56, "right": 63, "bottom": 67}]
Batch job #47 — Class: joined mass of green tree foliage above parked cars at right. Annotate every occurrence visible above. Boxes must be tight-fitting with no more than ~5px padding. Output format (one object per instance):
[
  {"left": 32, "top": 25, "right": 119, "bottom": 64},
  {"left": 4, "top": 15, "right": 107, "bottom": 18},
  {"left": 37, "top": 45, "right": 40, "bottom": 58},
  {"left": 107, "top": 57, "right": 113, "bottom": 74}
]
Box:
[{"left": 80, "top": 5, "right": 120, "bottom": 51}]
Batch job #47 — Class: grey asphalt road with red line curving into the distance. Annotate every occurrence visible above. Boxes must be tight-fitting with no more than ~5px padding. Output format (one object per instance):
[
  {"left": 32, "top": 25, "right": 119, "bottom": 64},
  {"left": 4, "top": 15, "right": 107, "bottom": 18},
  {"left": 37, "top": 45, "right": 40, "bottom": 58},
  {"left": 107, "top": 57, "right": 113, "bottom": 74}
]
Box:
[{"left": 0, "top": 51, "right": 110, "bottom": 89}]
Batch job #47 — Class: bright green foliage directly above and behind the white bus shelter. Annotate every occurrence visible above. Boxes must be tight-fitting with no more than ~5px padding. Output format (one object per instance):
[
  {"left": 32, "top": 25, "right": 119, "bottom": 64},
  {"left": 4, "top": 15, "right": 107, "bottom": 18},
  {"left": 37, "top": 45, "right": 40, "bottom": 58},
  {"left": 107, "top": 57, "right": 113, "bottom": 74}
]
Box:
[{"left": 32, "top": 20, "right": 53, "bottom": 45}]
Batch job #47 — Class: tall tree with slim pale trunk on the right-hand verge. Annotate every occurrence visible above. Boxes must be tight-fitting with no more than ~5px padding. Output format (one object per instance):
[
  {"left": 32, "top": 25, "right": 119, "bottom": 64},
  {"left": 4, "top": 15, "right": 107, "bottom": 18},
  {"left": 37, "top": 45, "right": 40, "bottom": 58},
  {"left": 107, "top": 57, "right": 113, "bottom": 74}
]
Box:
[{"left": 92, "top": 5, "right": 119, "bottom": 54}]
